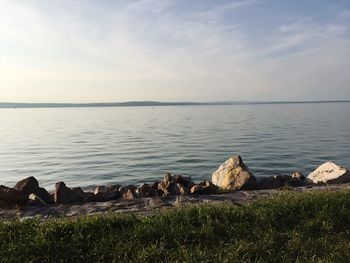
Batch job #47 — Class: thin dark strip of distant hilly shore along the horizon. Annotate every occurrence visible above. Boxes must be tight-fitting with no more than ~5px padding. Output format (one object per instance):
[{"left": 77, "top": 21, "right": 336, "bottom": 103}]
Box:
[{"left": 0, "top": 100, "right": 350, "bottom": 109}]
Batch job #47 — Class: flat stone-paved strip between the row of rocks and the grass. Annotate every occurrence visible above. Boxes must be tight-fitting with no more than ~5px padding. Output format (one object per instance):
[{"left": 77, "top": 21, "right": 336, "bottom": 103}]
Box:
[{"left": 0, "top": 183, "right": 350, "bottom": 221}]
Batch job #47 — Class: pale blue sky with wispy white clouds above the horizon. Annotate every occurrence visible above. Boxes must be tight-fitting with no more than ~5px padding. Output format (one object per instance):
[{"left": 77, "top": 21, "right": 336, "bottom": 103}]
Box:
[{"left": 0, "top": 0, "right": 350, "bottom": 102}]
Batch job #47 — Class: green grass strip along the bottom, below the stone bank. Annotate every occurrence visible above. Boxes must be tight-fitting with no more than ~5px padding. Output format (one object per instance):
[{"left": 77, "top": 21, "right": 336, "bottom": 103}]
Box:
[{"left": 0, "top": 190, "right": 350, "bottom": 262}]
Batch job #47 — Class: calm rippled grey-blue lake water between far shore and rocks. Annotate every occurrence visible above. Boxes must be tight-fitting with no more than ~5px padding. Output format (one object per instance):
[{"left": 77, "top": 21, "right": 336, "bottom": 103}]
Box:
[{"left": 0, "top": 103, "right": 350, "bottom": 189}]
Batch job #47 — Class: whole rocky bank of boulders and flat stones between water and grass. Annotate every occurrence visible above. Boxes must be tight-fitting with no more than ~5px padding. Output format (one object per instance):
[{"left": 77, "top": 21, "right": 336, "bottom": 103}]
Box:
[{"left": 0, "top": 156, "right": 350, "bottom": 220}]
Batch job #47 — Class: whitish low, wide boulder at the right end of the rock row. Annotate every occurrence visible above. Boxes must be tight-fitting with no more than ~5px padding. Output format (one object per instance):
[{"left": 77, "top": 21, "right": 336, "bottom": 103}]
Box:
[{"left": 307, "top": 162, "right": 350, "bottom": 184}]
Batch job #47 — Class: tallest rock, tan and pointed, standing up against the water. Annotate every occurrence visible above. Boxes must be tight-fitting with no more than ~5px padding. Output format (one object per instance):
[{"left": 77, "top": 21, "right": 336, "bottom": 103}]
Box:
[{"left": 212, "top": 156, "right": 257, "bottom": 190}]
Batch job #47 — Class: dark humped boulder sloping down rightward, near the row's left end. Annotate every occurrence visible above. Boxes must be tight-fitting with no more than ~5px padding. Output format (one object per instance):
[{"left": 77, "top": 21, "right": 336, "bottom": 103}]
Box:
[{"left": 14, "top": 176, "right": 54, "bottom": 204}]
